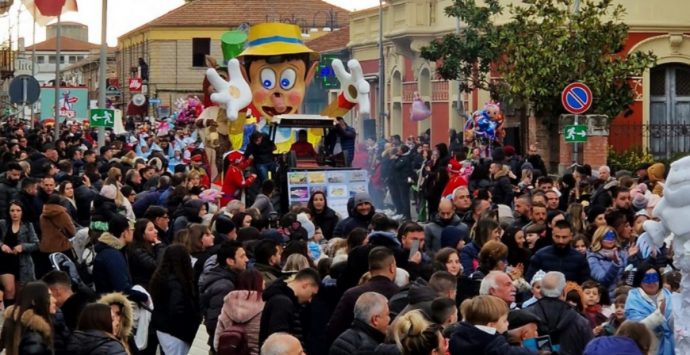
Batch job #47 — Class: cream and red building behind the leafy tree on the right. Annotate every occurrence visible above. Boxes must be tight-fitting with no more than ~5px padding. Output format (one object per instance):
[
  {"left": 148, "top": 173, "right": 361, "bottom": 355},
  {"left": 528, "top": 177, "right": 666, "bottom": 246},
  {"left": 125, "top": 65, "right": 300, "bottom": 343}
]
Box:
[{"left": 349, "top": 0, "right": 690, "bottom": 161}]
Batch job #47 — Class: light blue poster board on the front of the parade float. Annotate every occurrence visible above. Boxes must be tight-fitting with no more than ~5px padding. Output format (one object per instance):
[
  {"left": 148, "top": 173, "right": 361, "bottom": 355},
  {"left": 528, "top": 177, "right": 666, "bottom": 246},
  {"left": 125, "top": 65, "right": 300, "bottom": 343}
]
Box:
[{"left": 287, "top": 169, "right": 369, "bottom": 218}]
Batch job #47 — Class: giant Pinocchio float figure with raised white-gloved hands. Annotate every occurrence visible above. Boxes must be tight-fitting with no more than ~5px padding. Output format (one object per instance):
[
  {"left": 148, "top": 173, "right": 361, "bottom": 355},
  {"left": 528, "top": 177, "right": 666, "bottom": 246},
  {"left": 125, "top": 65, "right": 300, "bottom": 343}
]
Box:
[{"left": 199, "top": 23, "right": 369, "bottom": 156}]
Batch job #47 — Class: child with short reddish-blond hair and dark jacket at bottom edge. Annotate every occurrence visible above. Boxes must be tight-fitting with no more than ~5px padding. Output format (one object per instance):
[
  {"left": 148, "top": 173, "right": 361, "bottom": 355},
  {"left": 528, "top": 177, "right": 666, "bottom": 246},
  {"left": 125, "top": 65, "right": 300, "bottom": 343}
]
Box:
[{"left": 449, "top": 295, "right": 533, "bottom": 355}]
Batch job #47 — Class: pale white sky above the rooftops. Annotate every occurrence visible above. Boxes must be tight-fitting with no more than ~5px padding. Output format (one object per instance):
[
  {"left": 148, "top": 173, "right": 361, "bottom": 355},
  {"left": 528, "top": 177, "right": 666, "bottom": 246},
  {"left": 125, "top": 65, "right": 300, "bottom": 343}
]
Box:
[{"left": 0, "top": 0, "right": 379, "bottom": 46}]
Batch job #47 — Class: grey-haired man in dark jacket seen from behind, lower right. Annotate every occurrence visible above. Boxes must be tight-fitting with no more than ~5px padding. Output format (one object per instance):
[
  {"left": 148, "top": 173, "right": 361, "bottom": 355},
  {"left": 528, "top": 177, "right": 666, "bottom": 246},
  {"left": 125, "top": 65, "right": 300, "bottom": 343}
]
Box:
[{"left": 526, "top": 271, "right": 594, "bottom": 355}]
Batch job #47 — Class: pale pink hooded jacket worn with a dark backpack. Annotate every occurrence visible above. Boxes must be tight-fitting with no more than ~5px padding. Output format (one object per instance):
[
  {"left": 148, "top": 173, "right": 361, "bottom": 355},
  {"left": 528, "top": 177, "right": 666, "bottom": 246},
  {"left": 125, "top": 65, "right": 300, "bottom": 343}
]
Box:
[{"left": 213, "top": 290, "right": 264, "bottom": 355}]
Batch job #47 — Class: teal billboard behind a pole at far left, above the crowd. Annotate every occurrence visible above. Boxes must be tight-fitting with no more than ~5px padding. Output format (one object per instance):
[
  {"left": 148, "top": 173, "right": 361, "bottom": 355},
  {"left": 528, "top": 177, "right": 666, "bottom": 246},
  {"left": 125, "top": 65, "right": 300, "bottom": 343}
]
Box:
[{"left": 41, "top": 87, "right": 89, "bottom": 122}]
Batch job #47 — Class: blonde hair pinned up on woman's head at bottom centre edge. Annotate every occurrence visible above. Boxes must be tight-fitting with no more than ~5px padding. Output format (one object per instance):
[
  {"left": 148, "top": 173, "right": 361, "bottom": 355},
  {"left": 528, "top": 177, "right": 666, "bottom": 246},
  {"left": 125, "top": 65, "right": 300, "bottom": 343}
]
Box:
[{"left": 392, "top": 310, "right": 447, "bottom": 355}]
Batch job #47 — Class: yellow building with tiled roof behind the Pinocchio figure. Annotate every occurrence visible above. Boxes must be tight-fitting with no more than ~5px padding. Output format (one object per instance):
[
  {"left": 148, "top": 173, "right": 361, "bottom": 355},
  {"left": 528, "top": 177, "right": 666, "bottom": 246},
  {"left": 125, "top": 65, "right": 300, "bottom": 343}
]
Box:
[{"left": 118, "top": 0, "right": 349, "bottom": 118}]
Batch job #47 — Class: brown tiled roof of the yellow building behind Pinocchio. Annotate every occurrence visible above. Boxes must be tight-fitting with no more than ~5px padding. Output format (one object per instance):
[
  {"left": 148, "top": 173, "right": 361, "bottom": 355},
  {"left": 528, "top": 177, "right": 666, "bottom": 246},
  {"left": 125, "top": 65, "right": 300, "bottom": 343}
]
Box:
[{"left": 120, "top": 0, "right": 350, "bottom": 38}]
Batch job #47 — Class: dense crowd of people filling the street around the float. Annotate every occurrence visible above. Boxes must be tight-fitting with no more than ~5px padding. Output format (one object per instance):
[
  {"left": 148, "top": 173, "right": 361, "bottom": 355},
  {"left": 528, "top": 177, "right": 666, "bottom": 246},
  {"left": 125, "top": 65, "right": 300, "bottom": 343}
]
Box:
[{"left": 0, "top": 115, "right": 680, "bottom": 355}]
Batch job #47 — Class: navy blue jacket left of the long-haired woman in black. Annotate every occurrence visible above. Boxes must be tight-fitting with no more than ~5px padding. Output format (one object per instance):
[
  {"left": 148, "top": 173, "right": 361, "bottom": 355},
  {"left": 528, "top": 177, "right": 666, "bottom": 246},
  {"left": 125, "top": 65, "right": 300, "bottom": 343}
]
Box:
[{"left": 93, "top": 232, "right": 148, "bottom": 303}]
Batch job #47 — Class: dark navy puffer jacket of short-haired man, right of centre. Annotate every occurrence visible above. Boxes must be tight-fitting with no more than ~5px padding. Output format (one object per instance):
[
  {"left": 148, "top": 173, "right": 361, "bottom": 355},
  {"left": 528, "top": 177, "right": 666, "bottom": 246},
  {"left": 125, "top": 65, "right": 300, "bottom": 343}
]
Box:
[{"left": 524, "top": 245, "right": 590, "bottom": 284}]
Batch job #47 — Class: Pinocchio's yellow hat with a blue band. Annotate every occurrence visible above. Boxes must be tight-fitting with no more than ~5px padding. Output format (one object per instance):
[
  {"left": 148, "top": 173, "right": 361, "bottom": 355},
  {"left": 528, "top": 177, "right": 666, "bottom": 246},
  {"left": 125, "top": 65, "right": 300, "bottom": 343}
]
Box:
[{"left": 239, "top": 22, "right": 319, "bottom": 60}]
